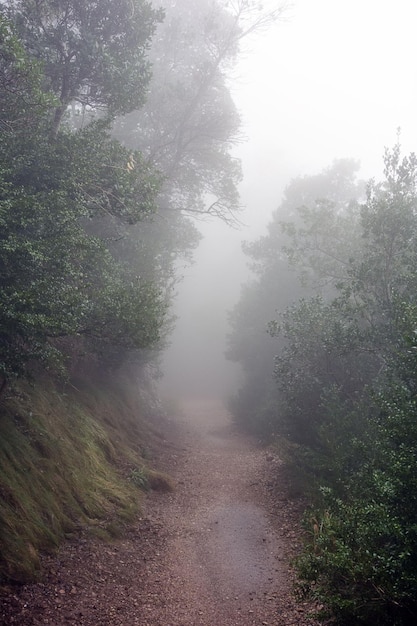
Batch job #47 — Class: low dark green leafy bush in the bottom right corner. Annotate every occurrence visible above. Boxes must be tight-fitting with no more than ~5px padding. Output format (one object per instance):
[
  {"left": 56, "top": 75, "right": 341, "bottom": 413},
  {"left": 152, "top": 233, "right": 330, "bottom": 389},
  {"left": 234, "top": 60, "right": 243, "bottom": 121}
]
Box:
[{"left": 297, "top": 481, "right": 417, "bottom": 626}]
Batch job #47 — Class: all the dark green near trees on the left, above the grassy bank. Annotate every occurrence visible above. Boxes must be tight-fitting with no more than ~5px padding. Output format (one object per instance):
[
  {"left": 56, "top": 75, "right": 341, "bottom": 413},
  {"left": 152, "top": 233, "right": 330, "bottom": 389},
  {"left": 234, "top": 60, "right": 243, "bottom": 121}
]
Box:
[{"left": 0, "top": 1, "right": 164, "bottom": 387}]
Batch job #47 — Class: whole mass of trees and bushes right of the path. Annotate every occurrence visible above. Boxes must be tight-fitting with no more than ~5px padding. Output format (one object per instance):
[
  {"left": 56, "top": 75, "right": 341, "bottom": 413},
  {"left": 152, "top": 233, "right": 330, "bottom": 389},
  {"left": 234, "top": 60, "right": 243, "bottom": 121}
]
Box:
[{"left": 229, "top": 145, "right": 417, "bottom": 625}]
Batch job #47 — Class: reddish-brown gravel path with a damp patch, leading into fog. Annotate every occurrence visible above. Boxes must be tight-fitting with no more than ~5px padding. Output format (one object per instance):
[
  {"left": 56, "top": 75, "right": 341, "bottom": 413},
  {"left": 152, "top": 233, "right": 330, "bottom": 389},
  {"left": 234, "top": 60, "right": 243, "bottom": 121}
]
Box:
[{"left": 0, "top": 400, "right": 316, "bottom": 626}]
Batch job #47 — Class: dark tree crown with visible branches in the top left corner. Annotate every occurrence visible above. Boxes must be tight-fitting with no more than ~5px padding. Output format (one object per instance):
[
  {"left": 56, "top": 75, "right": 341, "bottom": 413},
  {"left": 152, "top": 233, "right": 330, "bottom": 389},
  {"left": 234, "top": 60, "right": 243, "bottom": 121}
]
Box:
[{"left": 3, "top": 0, "right": 162, "bottom": 136}]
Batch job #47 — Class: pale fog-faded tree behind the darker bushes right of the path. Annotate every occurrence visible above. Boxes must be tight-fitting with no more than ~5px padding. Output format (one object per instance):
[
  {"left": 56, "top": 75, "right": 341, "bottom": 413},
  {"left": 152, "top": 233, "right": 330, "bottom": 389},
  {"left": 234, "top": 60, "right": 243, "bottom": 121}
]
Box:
[{"left": 227, "top": 159, "right": 363, "bottom": 436}]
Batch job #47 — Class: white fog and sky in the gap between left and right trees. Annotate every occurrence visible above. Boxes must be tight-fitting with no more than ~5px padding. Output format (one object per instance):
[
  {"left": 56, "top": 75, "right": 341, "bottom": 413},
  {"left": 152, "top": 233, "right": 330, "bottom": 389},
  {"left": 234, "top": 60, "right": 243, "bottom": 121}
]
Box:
[{"left": 158, "top": 0, "right": 417, "bottom": 396}]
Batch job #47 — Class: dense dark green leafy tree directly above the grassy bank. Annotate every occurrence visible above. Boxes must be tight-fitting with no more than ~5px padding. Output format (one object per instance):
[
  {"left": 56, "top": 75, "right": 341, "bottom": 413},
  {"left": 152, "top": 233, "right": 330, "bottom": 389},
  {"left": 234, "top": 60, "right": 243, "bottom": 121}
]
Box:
[{"left": 0, "top": 17, "right": 165, "bottom": 386}]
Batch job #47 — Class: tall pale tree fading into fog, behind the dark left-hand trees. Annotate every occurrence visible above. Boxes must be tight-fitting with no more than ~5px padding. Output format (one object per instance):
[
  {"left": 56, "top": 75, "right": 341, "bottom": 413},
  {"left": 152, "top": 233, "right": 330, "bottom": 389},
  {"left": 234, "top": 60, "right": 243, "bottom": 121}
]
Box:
[{"left": 115, "top": 0, "right": 280, "bottom": 222}]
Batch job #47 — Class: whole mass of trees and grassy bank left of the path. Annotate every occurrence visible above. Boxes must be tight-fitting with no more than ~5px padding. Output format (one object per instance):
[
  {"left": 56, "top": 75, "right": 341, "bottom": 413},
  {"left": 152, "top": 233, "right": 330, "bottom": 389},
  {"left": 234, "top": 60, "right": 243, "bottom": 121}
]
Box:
[{"left": 0, "top": 0, "right": 282, "bottom": 580}]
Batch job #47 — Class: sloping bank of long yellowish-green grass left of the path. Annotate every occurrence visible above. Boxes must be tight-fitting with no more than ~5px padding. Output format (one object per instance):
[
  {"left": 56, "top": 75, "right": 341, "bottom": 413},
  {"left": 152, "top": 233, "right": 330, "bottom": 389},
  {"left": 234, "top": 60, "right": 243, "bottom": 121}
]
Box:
[{"left": 0, "top": 370, "right": 170, "bottom": 581}]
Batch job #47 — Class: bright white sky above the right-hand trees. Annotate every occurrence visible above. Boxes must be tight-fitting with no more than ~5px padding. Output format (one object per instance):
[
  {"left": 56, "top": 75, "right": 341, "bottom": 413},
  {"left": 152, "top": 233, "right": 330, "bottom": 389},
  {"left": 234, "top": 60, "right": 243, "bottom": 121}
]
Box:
[{"left": 232, "top": 0, "right": 417, "bottom": 232}]
